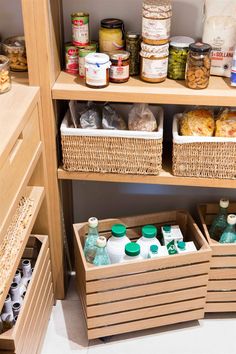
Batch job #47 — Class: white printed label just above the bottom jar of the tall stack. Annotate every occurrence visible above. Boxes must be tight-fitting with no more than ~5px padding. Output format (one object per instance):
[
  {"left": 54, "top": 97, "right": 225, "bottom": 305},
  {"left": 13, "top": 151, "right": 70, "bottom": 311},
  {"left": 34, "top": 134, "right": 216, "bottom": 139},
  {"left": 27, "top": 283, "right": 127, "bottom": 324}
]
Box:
[{"left": 142, "top": 17, "right": 170, "bottom": 41}]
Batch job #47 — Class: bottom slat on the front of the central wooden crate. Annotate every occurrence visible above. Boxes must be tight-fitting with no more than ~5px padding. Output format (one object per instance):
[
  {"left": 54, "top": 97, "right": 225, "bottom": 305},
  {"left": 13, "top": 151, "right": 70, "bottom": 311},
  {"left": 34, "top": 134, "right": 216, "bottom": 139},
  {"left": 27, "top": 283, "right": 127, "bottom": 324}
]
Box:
[{"left": 88, "top": 309, "right": 204, "bottom": 339}]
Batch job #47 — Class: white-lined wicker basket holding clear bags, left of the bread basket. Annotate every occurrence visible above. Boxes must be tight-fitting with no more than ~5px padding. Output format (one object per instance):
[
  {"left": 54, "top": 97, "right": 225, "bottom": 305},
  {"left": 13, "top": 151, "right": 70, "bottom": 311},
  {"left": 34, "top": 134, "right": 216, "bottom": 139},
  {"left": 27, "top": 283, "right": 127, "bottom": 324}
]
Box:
[{"left": 61, "top": 106, "right": 163, "bottom": 175}]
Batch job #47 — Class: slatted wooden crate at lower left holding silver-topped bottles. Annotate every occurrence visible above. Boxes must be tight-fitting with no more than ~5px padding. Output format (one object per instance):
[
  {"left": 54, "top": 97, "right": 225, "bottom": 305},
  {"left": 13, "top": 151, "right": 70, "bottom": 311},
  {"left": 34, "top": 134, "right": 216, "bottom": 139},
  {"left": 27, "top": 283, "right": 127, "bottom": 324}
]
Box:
[{"left": 0, "top": 235, "right": 53, "bottom": 354}]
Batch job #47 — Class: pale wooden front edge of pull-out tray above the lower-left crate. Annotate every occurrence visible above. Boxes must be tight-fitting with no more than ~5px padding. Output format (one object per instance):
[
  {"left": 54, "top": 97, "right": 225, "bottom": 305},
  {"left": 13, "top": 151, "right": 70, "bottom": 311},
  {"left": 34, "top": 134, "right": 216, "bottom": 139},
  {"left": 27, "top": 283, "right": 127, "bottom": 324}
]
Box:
[{"left": 0, "top": 187, "right": 45, "bottom": 309}]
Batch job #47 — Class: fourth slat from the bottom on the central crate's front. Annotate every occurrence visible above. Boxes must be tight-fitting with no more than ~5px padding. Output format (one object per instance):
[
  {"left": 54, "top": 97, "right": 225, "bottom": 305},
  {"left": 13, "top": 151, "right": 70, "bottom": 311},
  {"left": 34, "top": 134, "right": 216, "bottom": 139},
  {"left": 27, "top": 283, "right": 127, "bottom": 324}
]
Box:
[{"left": 86, "top": 275, "right": 208, "bottom": 305}]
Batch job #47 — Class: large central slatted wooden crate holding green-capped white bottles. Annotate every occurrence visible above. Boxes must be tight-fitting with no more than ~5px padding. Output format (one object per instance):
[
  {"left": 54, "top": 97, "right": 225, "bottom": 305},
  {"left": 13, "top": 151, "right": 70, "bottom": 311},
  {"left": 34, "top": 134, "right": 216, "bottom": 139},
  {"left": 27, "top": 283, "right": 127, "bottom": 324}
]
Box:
[{"left": 74, "top": 211, "right": 211, "bottom": 339}]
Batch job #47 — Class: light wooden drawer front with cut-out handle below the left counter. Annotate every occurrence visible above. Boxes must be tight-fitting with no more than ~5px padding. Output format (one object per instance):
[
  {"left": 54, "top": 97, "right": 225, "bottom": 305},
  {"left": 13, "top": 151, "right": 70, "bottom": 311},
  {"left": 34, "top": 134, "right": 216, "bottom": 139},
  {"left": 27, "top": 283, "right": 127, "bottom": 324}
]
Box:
[{"left": 0, "top": 105, "right": 40, "bottom": 225}]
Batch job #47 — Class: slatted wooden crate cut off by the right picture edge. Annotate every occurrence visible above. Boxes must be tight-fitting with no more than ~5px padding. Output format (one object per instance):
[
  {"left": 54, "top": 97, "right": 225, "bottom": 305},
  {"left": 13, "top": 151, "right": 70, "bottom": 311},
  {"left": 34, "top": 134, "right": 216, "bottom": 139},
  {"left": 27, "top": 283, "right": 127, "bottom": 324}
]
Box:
[{"left": 198, "top": 203, "right": 236, "bottom": 312}]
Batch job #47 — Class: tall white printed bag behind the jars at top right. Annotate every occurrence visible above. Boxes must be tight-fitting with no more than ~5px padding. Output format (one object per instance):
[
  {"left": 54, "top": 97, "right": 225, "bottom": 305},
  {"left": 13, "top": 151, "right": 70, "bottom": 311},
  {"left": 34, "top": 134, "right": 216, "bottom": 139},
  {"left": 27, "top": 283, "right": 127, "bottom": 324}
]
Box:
[{"left": 202, "top": 0, "right": 236, "bottom": 77}]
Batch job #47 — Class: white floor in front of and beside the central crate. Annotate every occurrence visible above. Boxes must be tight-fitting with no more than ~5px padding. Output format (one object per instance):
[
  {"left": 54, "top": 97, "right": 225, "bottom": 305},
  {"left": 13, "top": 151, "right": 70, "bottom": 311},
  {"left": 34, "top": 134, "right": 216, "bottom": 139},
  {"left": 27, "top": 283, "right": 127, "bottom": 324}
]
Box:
[{"left": 42, "top": 278, "right": 236, "bottom": 354}]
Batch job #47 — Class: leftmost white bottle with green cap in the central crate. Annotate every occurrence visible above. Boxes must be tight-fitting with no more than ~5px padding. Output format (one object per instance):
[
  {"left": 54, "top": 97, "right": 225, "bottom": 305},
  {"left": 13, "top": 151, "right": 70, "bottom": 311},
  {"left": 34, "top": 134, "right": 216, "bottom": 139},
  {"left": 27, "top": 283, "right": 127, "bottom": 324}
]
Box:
[{"left": 107, "top": 224, "right": 130, "bottom": 263}]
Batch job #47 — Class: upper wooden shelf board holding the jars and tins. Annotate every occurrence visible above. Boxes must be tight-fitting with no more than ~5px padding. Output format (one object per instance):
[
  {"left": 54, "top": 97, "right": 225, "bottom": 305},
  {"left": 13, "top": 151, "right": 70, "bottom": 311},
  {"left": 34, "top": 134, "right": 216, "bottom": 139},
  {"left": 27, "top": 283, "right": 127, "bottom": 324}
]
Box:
[{"left": 52, "top": 72, "right": 236, "bottom": 107}]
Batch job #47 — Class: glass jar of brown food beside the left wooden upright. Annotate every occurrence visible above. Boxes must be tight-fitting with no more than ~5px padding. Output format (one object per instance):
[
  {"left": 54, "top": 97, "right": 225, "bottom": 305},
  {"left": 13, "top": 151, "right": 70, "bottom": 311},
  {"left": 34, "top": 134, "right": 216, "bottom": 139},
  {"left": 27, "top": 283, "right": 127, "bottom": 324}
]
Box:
[{"left": 2, "top": 36, "right": 28, "bottom": 71}]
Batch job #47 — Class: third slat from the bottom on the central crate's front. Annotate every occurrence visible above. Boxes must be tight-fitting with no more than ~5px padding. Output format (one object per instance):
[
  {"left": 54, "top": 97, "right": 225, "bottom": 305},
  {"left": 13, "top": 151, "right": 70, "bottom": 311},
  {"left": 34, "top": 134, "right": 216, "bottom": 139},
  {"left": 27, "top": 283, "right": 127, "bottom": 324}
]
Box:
[{"left": 87, "top": 286, "right": 207, "bottom": 318}]
